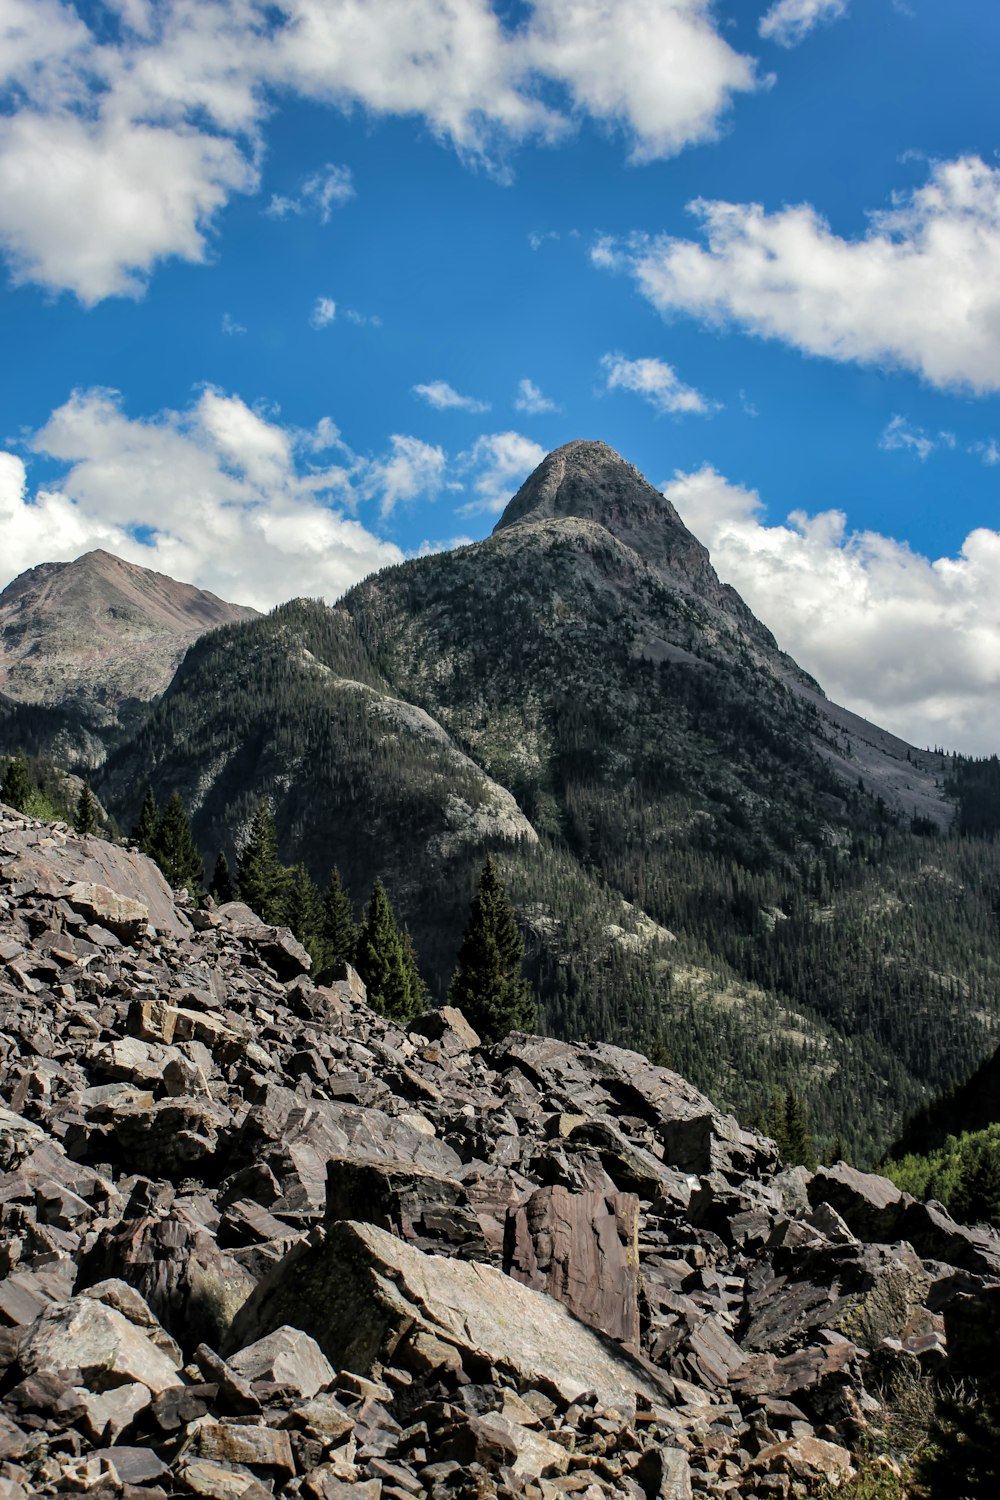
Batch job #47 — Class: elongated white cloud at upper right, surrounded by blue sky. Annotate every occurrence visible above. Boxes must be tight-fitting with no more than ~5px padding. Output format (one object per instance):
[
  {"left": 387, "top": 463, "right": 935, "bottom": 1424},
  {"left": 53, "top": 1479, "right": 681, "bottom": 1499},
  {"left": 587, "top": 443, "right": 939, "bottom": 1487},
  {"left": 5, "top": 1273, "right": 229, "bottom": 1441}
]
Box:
[{"left": 592, "top": 156, "right": 1000, "bottom": 392}]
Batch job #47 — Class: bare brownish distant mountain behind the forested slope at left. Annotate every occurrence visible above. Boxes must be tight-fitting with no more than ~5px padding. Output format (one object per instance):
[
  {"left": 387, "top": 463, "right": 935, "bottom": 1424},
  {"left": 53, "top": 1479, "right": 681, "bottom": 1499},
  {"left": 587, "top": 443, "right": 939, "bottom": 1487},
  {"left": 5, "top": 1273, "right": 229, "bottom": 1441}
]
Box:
[{"left": 0, "top": 551, "right": 256, "bottom": 764}]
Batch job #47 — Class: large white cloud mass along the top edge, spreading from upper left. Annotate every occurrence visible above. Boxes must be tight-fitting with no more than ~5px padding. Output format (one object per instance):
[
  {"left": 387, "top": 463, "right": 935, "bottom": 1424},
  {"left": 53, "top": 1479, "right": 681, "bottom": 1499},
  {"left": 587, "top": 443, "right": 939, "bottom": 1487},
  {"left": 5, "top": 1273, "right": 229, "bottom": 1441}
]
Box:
[{"left": 0, "top": 0, "right": 757, "bottom": 305}]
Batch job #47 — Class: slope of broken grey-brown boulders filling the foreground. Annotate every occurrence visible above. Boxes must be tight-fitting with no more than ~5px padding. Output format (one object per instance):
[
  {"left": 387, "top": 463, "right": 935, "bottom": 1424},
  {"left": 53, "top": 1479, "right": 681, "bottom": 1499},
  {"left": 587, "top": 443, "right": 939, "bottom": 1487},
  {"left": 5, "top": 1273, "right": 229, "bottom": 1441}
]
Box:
[{"left": 0, "top": 809, "right": 1000, "bottom": 1500}]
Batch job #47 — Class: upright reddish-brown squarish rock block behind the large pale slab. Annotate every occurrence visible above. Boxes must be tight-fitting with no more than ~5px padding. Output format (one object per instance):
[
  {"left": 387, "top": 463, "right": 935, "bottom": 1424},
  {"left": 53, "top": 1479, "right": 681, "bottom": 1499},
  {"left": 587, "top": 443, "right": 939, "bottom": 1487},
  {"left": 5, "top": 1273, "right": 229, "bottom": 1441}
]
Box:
[{"left": 504, "top": 1187, "right": 639, "bottom": 1350}]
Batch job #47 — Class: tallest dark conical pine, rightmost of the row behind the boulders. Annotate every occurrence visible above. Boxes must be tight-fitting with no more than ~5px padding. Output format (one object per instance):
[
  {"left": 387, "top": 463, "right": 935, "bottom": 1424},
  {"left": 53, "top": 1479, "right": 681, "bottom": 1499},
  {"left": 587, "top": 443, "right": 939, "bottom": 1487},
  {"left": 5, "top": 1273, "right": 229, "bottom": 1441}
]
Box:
[{"left": 448, "top": 857, "right": 538, "bottom": 1041}]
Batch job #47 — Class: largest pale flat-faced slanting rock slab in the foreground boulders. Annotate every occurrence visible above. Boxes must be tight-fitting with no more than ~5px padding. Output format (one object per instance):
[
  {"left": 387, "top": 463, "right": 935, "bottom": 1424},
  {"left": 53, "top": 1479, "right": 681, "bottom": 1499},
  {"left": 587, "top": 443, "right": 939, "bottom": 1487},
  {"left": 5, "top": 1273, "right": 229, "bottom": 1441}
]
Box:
[{"left": 234, "top": 1223, "right": 673, "bottom": 1416}]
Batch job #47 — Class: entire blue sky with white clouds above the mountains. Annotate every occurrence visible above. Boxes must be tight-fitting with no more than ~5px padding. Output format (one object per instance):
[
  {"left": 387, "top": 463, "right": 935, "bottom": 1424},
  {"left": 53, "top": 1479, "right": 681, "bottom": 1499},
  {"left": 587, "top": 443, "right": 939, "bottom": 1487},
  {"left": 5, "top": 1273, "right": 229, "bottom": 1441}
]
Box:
[{"left": 0, "top": 0, "right": 1000, "bottom": 752}]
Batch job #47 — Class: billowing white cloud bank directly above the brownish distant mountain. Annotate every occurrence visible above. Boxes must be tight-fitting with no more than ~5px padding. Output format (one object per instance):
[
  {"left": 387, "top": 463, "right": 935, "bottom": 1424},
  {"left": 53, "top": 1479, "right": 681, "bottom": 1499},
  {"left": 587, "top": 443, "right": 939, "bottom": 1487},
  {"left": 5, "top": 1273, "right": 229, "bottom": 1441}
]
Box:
[{"left": 0, "top": 390, "right": 402, "bottom": 609}]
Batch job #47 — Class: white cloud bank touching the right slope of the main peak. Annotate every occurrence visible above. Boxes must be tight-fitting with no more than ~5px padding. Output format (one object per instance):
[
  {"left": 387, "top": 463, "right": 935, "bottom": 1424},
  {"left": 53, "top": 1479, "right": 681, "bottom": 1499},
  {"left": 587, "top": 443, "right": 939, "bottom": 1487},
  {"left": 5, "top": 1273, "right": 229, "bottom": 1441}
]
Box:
[{"left": 663, "top": 465, "right": 1000, "bottom": 753}]
